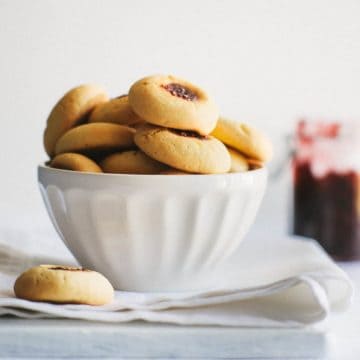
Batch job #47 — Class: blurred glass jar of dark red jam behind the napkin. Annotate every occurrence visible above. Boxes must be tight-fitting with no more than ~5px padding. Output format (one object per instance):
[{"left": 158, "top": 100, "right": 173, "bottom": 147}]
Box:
[{"left": 292, "top": 121, "right": 360, "bottom": 260}]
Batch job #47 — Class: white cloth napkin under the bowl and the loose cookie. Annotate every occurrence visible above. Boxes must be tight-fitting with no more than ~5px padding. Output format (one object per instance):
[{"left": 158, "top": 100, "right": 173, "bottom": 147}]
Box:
[{"left": 0, "top": 237, "right": 352, "bottom": 327}]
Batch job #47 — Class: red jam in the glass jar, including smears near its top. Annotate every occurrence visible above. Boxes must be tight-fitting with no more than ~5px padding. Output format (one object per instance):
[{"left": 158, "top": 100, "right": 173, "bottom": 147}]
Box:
[{"left": 293, "top": 122, "right": 360, "bottom": 260}]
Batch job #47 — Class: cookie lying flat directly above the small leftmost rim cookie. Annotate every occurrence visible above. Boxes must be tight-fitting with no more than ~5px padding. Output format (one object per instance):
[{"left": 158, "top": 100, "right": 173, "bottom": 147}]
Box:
[{"left": 55, "top": 123, "right": 135, "bottom": 154}]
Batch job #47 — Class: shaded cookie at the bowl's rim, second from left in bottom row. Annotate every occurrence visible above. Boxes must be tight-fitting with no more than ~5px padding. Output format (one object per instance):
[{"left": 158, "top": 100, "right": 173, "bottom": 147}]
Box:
[{"left": 100, "top": 150, "right": 168, "bottom": 174}]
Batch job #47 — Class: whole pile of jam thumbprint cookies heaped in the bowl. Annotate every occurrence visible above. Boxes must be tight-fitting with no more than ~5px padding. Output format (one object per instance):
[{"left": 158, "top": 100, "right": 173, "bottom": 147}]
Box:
[{"left": 44, "top": 75, "right": 272, "bottom": 174}]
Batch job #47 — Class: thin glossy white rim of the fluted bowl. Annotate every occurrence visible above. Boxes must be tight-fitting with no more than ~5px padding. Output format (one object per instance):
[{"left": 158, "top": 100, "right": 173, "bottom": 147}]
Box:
[{"left": 38, "top": 163, "right": 267, "bottom": 179}]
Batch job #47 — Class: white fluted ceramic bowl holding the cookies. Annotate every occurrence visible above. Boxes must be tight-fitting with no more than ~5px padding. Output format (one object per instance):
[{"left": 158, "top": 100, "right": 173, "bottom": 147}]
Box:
[{"left": 38, "top": 166, "right": 267, "bottom": 291}]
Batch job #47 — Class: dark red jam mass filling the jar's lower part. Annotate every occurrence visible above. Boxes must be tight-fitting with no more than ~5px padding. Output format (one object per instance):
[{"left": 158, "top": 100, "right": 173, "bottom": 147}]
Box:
[{"left": 294, "top": 163, "right": 360, "bottom": 260}]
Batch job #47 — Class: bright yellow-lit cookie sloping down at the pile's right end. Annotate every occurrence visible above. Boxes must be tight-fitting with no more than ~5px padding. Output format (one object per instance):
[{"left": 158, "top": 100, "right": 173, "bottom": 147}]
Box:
[{"left": 211, "top": 118, "right": 273, "bottom": 162}]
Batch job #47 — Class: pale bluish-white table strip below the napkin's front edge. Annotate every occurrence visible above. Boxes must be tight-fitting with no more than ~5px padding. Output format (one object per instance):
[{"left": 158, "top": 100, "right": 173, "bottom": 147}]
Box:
[{"left": 0, "top": 319, "right": 327, "bottom": 359}]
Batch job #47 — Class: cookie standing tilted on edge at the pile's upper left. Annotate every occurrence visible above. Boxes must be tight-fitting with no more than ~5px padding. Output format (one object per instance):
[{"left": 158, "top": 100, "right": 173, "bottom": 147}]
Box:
[{"left": 44, "top": 84, "right": 109, "bottom": 157}]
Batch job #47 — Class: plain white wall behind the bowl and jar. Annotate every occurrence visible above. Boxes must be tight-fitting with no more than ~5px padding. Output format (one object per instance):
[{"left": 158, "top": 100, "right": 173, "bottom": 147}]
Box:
[{"left": 0, "top": 0, "right": 360, "bottom": 236}]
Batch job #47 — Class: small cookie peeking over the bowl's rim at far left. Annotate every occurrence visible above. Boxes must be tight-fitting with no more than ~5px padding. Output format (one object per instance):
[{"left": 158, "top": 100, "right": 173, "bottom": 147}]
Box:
[{"left": 50, "top": 153, "right": 102, "bottom": 173}]
